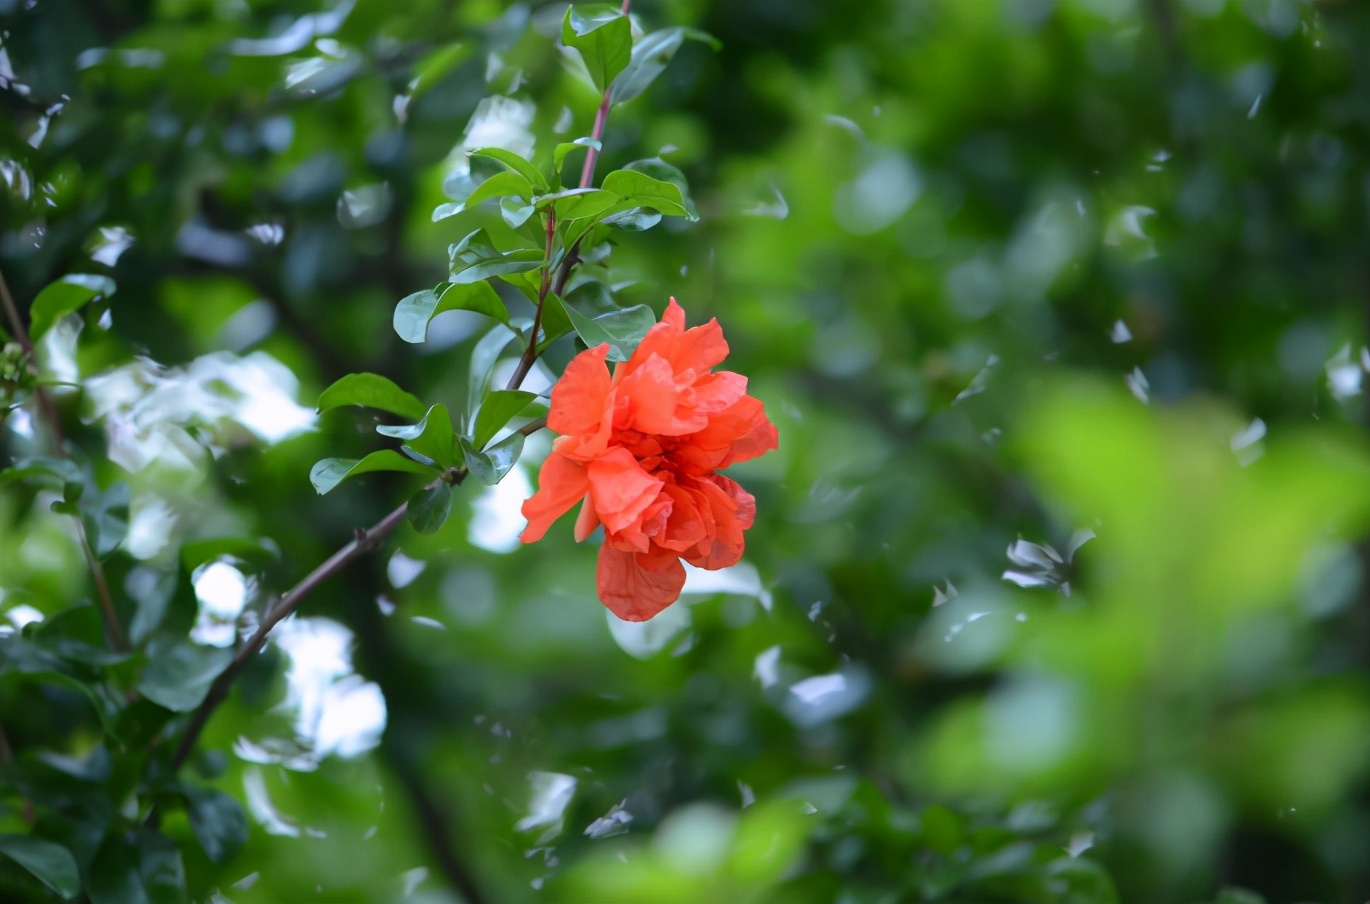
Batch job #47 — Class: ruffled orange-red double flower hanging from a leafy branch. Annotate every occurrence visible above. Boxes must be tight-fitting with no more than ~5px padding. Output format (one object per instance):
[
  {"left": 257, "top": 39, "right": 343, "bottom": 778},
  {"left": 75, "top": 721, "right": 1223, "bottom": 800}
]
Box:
[{"left": 522, "top": 299, "right": 777, "bottom": 622}]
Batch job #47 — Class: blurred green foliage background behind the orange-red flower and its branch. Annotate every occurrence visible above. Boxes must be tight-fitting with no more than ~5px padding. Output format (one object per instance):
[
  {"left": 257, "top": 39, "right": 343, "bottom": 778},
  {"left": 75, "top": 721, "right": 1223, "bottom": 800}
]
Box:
[{"left": 0, "top": 0, "right": 1370, "bottom": 904}]
